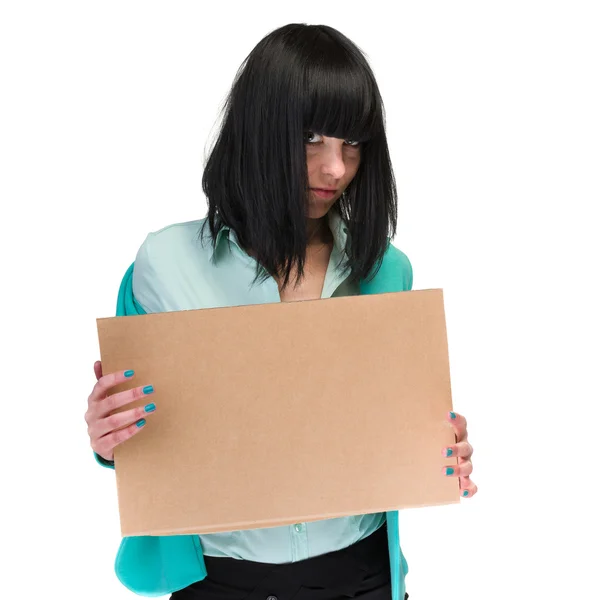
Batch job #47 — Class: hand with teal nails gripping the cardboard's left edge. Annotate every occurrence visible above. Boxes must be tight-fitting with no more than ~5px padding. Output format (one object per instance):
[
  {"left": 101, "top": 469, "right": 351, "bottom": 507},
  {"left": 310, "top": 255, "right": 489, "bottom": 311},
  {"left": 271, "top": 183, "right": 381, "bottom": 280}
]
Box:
[{"left": 85, "top": 360, "right": 156, "bottom": 461}]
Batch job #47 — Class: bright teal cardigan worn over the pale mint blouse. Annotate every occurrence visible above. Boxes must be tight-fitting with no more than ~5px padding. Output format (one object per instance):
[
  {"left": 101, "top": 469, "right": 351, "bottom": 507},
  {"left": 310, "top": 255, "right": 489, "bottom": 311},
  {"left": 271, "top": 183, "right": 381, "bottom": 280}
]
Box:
[{"left": 94, "top": 244, "right": 413, "bottom": 600}]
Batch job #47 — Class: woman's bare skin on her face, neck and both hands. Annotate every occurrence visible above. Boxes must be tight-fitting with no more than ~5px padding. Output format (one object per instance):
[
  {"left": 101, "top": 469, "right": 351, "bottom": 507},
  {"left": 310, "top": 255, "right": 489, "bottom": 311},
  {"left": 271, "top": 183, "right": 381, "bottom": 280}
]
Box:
[{"left": 85, "top": 132, "right": 477, "bottom": 498}]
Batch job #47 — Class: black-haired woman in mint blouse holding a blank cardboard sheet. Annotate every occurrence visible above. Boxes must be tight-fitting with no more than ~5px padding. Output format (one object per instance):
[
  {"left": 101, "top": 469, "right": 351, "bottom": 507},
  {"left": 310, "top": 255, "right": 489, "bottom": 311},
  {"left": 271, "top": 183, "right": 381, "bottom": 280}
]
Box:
[{"left": 86, "top": 24, "right": 477, "bottom": 600}]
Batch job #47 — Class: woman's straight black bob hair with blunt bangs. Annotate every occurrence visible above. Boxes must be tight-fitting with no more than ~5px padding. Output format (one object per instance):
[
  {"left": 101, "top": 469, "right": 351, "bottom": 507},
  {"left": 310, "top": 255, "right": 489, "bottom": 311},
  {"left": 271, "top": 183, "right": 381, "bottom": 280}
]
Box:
[{"left": 202, "top": 23, "right": 397, "bottom": 287}]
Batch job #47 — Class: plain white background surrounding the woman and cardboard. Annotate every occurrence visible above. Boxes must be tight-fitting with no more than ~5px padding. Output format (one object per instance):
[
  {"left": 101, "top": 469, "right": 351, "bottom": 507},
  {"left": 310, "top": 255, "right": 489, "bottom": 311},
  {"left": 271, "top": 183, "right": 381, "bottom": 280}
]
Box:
[{"left": 0, "top": 0, "right": 600, "bottom": 600}]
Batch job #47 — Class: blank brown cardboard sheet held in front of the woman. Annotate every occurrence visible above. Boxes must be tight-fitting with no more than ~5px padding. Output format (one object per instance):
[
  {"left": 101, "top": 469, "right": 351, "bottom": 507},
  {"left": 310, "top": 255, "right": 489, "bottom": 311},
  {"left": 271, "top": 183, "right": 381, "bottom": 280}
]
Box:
[{"left": 97, "top": 289, "right": 460, "bottom": 536}]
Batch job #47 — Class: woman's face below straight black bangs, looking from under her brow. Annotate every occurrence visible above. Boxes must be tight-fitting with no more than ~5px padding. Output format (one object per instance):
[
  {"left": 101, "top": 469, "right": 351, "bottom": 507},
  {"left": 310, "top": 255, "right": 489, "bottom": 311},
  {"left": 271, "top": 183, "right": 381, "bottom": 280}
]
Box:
[{"left": 305, "top": 131, "right": 361, "bottom": 219}]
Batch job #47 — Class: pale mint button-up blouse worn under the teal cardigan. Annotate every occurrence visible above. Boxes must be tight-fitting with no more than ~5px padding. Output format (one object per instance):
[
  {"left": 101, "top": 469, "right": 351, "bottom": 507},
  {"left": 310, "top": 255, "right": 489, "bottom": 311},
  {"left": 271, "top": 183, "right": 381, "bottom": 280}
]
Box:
[{"left": 132, "top": 211, "right": 385, "bottom": 563}]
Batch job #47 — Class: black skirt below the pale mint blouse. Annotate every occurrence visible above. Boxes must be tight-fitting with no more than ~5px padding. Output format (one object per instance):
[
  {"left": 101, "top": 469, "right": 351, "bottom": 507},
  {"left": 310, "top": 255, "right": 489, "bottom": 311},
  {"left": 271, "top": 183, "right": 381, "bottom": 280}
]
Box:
[{"left": 170, "top": 523, "right": 408, "bottom": 600}]
